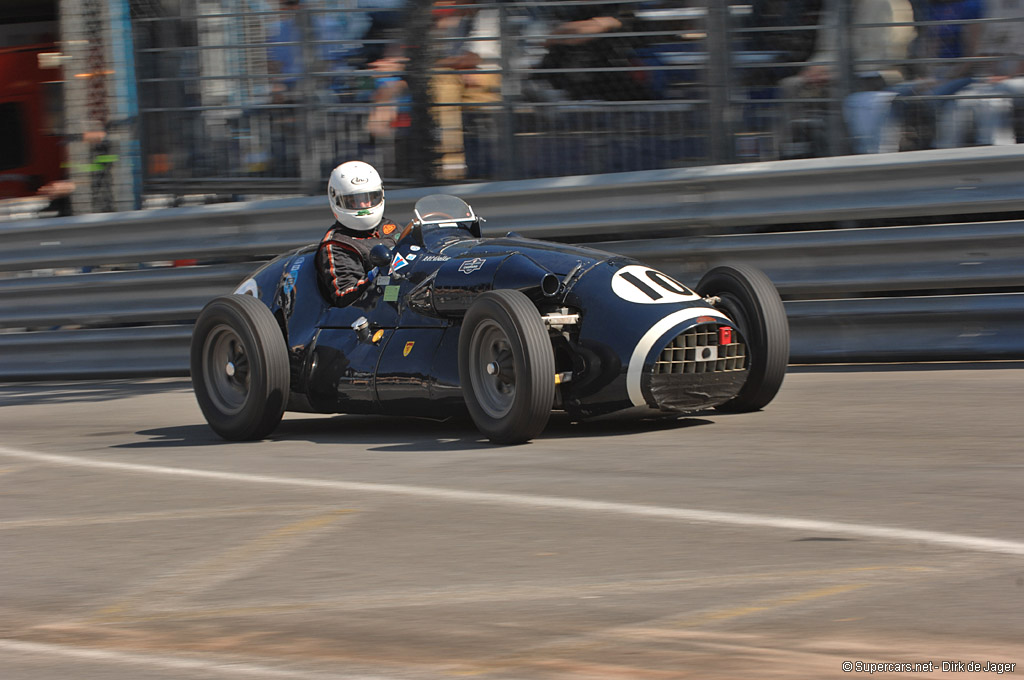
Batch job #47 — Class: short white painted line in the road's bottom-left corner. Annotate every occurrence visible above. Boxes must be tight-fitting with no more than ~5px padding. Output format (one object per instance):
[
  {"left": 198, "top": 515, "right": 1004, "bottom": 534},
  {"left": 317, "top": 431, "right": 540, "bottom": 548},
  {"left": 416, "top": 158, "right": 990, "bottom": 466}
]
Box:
[{"left": 0, "top": 639, "right": 389, "bottom": 680}]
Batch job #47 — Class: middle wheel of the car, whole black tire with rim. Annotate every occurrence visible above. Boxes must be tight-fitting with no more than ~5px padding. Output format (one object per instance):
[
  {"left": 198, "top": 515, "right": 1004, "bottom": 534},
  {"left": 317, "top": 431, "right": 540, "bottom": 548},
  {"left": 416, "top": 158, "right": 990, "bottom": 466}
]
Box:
[{"left": 459, "top": 290, "right": 555, "bottom": 444}]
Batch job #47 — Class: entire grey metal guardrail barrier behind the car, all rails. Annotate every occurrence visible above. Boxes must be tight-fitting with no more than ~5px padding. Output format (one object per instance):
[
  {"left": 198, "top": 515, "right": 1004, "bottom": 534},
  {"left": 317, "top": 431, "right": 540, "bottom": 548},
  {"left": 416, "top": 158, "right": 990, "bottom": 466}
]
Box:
[{"left": 0, "top": 148, "right": 1024, "bottom": 380}]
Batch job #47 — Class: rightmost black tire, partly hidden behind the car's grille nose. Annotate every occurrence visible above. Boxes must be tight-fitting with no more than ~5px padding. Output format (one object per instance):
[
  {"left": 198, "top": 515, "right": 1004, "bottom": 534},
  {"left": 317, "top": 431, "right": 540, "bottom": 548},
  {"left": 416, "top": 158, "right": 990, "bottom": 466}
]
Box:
[{"left": 696, "top": 264, "right": 790, "bottom": 413}]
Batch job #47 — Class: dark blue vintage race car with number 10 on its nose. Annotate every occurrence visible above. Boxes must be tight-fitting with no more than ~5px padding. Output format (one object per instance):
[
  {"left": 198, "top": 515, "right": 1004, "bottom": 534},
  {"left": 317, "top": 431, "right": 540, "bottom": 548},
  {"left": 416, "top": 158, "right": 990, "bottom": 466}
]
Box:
[{"left": 191, "top": 195, "right": 790, "bottom": 443}]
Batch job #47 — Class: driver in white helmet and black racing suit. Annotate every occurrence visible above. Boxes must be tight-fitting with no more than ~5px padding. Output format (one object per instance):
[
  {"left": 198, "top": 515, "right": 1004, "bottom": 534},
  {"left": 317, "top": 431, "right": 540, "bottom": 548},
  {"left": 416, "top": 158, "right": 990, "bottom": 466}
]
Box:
[{"left": 316, "top": 161, "right": 399, "bottom": 306}]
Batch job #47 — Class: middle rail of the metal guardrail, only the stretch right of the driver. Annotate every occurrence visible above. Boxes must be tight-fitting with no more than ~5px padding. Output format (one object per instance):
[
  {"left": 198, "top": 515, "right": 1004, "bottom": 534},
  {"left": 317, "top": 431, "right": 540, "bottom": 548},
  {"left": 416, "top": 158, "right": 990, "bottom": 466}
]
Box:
[{"left": 592, "top": 220, "right": 1024, "bottom": 299}]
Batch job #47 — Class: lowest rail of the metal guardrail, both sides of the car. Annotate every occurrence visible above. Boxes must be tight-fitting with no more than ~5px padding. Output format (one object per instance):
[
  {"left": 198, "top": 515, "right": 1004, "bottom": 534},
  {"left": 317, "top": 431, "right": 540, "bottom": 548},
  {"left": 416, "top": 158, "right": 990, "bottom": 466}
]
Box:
[{"left": 0, "top": 293, "right": 1024, "bottom": 381}]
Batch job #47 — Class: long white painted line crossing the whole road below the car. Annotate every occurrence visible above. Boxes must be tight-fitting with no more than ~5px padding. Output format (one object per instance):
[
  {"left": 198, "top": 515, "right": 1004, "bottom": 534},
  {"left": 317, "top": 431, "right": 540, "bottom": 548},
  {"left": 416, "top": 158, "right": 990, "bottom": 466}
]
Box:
[{"left": 0, "top": 447, "right": 1024, "bottom": 555}]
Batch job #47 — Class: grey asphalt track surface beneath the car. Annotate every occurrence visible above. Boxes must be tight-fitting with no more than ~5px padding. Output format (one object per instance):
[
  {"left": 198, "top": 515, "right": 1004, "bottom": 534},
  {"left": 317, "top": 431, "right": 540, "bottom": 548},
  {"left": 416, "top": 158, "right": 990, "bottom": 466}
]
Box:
[{"left": 0, "top": 364, "right": 1024, "bottom": 680}]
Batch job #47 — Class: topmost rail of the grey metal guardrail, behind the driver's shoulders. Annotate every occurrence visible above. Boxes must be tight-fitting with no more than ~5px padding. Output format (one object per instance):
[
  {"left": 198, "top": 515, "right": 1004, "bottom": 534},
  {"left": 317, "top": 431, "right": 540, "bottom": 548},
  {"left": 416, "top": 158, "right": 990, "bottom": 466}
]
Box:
[{"left": 0, "top": 146, "right": 1024, "bottom": 271}]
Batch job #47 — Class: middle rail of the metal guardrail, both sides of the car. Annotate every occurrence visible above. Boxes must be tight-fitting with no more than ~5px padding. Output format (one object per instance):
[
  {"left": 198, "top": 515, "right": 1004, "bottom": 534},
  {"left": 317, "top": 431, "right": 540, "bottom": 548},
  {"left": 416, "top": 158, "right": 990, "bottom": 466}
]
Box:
[{"left": 8, "top": 221, "right": 1024, "bottom": 328}]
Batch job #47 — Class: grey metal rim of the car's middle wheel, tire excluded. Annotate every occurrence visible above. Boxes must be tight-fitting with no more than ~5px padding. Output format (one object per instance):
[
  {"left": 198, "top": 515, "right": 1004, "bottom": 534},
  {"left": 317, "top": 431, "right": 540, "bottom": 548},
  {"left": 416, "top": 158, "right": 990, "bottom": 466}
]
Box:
[{"left": 469, "top": 320, "right": 516, "bottom": 419}]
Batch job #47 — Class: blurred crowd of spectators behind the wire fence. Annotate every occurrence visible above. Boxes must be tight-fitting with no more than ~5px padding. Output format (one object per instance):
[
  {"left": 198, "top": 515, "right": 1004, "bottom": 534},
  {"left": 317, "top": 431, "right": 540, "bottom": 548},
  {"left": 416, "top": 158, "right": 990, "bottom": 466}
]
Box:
[{"left": 143, "top": 0, "right": 1024, "bottom": 186}]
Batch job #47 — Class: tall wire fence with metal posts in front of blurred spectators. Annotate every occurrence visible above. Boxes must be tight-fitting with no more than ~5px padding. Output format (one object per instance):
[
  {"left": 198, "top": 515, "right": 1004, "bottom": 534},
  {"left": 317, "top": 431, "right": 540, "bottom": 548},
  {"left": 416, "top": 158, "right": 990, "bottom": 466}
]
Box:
[{"left": 133, "top": 0, "right": 1024, "bottom": 194}]
